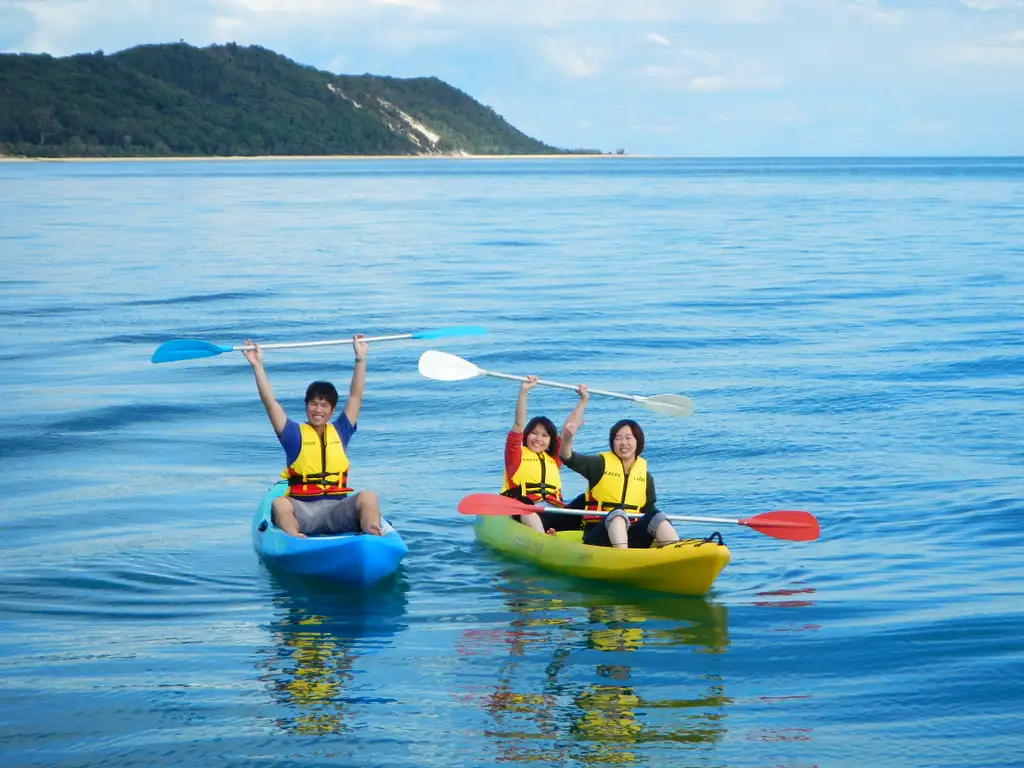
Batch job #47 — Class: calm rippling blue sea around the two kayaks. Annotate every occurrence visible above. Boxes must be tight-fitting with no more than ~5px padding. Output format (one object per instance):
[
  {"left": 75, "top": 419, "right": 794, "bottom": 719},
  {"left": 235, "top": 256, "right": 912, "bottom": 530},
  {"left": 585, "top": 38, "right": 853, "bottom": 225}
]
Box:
[{"left": 0, "top": 158, "right": 1024, "bottom": 768}]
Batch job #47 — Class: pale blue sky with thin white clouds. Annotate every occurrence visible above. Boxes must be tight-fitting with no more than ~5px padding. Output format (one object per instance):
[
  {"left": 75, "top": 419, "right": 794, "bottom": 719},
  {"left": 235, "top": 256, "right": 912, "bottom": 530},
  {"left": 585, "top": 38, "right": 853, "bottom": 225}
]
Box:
[{"left": 0, "top": 0, "right": 1024, "bottom": 157}]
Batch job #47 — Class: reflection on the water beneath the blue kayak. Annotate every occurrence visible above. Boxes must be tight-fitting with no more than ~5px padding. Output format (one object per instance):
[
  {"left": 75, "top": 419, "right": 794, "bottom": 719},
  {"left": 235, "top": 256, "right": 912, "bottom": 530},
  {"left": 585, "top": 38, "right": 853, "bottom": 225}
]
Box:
[{"left": 257, "top": 573, "right": 408, "bottom": 735}]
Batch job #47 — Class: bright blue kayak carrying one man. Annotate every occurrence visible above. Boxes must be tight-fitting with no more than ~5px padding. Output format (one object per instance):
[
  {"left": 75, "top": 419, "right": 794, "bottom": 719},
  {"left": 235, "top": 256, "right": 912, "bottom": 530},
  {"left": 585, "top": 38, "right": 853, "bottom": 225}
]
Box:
[{"left": 252, "top": 481, "right": 409, "bottom": 587}]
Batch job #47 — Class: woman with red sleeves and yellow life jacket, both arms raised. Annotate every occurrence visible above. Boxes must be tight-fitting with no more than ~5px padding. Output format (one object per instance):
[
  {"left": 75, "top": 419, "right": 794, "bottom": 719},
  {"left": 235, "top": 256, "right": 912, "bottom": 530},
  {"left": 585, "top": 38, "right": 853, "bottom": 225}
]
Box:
[{"left": 502, "top": 376, "right": 590, "bottom": 534}]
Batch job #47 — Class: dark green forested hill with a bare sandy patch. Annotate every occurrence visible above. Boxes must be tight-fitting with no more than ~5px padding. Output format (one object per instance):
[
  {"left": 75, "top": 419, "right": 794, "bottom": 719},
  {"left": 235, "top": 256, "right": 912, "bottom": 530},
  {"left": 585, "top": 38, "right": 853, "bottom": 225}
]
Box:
[{"left": 0, "top": 43, "right": 562, "bottom": 157}]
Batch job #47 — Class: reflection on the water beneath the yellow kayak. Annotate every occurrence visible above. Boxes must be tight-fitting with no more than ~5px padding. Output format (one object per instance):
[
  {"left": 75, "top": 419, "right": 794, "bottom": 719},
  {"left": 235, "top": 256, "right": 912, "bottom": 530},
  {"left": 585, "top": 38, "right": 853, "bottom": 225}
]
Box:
[{"left": 459, "top": 579, "right": 731, "bottom": 765}]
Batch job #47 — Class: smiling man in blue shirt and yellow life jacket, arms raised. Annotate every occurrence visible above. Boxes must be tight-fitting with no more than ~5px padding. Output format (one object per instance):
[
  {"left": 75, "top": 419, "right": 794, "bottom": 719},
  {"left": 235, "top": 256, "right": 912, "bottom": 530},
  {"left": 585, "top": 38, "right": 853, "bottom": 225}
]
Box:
[{"left": 243, "top": 334, "right": 383, "bottom": 538}]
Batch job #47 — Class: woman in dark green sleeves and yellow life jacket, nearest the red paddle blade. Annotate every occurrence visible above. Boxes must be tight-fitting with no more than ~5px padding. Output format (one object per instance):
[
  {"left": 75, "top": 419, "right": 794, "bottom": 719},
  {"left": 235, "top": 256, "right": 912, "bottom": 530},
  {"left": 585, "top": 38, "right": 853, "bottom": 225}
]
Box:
[{"left": 559, "top": 405, "right": 679, "bottom": 549}]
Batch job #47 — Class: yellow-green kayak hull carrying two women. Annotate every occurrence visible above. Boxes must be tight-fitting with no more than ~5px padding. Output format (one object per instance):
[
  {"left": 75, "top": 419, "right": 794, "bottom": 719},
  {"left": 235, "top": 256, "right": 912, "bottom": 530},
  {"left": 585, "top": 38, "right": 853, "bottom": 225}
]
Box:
[{"left": 473, "top": 515, "right": 729, "bottom": 596}]
